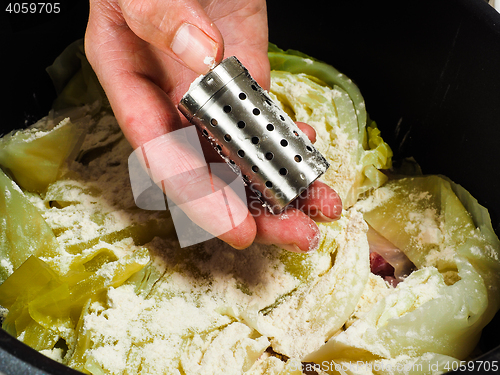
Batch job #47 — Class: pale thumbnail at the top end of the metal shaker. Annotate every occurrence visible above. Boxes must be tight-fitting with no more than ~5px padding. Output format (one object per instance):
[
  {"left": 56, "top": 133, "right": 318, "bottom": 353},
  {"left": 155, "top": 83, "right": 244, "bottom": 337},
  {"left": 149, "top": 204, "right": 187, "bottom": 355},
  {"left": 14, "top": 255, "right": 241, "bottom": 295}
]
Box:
[{"left": 170, "top": 23, "right": 217, "bottom": 74}]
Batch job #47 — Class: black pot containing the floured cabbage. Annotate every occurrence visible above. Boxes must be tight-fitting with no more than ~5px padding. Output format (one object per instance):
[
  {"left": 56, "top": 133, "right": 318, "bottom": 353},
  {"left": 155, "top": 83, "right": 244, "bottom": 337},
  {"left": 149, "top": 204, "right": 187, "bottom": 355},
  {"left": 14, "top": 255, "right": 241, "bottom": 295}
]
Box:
[{"left": 0, "top": 0, "right": 500, "bottom": 374}]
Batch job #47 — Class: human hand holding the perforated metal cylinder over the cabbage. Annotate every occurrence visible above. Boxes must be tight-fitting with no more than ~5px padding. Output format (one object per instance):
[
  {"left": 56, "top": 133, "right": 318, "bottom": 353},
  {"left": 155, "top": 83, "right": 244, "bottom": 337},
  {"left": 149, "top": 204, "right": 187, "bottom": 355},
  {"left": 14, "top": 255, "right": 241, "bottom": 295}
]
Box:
[{"left": 85, "top": 0, "right": 342, "bottom": 252}]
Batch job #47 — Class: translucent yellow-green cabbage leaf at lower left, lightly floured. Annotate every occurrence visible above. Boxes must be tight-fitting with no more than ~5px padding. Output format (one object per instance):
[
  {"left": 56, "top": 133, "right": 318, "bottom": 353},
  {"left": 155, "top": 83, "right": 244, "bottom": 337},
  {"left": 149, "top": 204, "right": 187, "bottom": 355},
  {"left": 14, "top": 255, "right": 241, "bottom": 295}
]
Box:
[{"left": 0, "top": 245, "right": 149, "bottom": 350}]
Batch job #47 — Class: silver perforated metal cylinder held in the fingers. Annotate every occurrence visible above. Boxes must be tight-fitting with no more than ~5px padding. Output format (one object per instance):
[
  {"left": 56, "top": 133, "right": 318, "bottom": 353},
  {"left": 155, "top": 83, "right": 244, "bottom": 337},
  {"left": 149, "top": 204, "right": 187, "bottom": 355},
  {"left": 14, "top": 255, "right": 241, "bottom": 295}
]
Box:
[{"left": 179, "top": 56, "right": 329, "bottom": 214}]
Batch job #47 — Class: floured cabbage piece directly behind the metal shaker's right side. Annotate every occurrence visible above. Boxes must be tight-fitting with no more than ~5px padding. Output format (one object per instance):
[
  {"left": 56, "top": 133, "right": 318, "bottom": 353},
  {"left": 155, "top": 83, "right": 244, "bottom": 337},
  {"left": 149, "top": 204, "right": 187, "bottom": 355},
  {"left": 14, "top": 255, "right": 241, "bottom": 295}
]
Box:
[{"left": 270, "top": 71, "right": 392, "bottom": 208}]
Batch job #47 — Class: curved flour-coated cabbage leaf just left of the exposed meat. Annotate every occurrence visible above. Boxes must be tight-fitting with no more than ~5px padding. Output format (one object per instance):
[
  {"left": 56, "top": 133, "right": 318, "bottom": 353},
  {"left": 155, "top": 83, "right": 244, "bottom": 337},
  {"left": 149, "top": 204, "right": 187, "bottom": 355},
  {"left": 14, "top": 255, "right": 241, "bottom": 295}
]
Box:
[{"left": 260, "top": 210, "right": 370, "bottom": 358}]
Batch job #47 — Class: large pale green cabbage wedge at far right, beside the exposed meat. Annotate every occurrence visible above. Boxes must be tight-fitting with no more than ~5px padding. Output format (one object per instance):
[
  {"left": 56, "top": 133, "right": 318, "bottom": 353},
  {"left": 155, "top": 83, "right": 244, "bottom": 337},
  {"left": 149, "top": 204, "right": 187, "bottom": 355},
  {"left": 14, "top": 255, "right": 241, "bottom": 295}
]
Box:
[{"left": 306, "top": 176, "right": 500, "bottom": 370}]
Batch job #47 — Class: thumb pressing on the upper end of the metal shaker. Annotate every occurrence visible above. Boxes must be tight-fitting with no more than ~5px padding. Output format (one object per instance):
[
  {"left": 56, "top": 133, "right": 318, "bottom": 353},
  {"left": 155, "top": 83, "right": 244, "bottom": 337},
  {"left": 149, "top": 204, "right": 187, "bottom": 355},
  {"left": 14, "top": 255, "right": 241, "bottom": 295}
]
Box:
[{"left": 118, "top": 0, "right": 224, "bottom": 74}]
